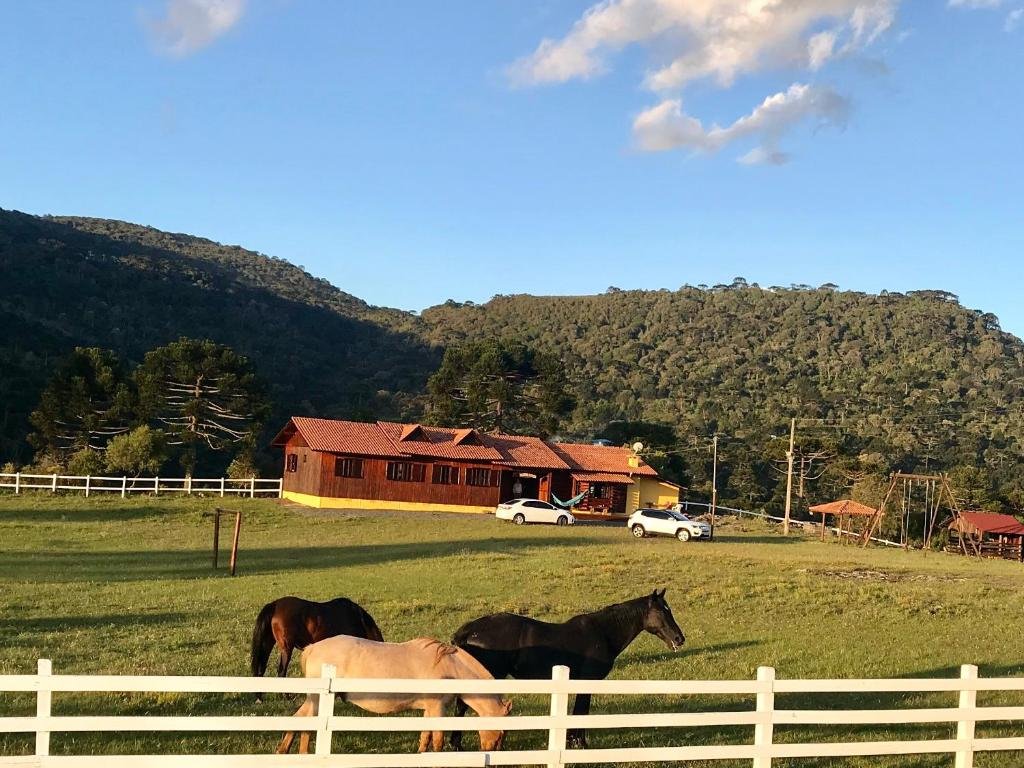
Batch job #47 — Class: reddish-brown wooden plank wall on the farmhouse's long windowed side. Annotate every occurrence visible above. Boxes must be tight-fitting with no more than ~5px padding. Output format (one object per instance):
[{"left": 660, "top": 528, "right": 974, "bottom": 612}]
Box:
[{"left": 319, "top": 454, "right": 507, "bottom": 507}]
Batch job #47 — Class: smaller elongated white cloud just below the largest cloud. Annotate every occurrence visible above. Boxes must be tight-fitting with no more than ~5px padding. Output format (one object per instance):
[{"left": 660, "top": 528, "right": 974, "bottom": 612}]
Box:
[{"left": 633, "top": 83, "right": 849, "bottom": 165}]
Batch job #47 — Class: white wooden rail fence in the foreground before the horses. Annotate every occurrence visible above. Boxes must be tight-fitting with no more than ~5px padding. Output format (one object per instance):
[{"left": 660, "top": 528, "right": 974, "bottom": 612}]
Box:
[{"left": 0, "top": 659, "right": 1024, "bottom": 768}]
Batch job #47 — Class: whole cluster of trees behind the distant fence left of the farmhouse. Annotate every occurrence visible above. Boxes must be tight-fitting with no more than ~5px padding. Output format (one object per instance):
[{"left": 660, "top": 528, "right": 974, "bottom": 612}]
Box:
[{"left": 20, "top": 338, "right": 269, "bottom": 477}]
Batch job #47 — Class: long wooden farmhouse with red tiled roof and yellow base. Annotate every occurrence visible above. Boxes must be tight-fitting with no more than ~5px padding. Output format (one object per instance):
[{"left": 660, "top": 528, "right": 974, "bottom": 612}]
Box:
[{"left": 273, "top": 416, "right": 679, "bottom": 514}]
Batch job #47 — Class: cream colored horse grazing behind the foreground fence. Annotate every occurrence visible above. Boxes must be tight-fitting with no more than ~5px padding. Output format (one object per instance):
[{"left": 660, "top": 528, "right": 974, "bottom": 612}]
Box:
[{"left": 278, "top": 635, "right": 512, "bottom": 754}]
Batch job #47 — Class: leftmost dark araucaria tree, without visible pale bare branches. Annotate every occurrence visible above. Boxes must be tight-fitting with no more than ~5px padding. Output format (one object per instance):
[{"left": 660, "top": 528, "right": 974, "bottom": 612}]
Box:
[{"left": 29, "top": 347, "right": 133, "bottom": 463}]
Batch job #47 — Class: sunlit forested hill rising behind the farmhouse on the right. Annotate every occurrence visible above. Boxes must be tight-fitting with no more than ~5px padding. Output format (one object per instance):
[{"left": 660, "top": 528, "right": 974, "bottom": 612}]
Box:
[{"left": 423, "top": 281, "right": 1024, "bottom": 503}]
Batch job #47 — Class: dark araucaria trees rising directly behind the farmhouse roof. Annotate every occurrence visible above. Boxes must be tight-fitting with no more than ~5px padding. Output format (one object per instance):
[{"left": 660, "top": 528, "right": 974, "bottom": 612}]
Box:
[{"left": 427, "top": 339, "right": 573, "bottom": 435}]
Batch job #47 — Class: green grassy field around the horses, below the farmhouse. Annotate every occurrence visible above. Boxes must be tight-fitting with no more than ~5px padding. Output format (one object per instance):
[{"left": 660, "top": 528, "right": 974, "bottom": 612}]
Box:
[{"left": 0, "top": 496, "right": 1024, "bottom": 768}]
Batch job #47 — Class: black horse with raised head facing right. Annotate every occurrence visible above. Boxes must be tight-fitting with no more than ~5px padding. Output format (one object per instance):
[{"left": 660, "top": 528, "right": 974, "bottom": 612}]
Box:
[{"left": 452, "top": 590, "right": 686, "bottom": 750}]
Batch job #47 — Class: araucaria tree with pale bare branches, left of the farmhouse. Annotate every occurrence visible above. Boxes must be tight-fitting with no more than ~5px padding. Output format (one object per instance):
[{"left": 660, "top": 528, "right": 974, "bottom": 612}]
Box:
[{"left": 135, "top": 339, "right": 268, "bottom": 474}]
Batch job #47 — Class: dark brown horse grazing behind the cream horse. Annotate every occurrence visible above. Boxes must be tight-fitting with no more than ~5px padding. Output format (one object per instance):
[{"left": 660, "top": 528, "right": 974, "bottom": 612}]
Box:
[{"left": 251, "top": 596, "right": 384, "bottom": 677}]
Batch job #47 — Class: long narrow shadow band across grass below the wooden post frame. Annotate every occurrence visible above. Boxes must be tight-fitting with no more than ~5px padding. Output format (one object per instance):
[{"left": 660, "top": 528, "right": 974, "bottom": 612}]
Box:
[{"left": 0, "top": 537, "right": 589, "bottom": 584}]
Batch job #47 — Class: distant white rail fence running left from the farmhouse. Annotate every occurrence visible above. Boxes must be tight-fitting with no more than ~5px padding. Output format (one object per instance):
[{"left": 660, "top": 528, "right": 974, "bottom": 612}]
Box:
[{"left": 0, "top": 472, "right": 282, "bottom": 499}]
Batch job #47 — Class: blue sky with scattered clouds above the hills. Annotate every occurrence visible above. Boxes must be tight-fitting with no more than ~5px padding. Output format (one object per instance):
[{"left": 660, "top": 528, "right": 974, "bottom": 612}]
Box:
[{"left": 0, "top": 0, "right": 1024, "bottom": 335}]
